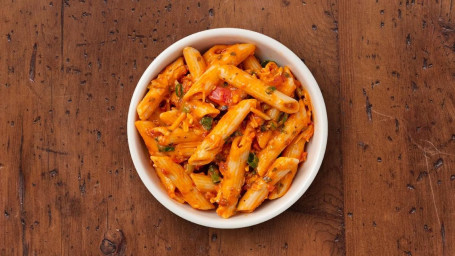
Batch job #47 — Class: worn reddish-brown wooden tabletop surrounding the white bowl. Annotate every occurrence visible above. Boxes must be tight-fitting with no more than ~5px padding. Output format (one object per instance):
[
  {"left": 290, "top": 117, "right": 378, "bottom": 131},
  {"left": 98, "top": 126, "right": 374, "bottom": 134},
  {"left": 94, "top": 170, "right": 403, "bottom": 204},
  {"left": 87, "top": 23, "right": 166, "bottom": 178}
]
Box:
[{"left": 0, "top": 0, "right": 455, "bottom": 255}]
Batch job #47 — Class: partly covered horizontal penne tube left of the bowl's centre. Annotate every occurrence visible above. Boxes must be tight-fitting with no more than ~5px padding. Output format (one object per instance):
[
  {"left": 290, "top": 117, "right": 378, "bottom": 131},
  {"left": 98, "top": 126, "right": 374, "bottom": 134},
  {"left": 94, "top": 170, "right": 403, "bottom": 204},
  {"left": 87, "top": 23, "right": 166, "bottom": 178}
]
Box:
[{"left": 152, "top": 127, "right": 205, "bottom": 145}]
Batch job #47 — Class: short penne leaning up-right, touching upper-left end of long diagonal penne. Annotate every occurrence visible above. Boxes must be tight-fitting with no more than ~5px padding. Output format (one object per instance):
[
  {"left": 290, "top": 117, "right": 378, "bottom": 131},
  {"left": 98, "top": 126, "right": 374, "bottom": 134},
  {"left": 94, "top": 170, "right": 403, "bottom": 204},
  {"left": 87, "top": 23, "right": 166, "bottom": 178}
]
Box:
[{"left": 183, "top": 65, "right": 220, "bottom": 101}]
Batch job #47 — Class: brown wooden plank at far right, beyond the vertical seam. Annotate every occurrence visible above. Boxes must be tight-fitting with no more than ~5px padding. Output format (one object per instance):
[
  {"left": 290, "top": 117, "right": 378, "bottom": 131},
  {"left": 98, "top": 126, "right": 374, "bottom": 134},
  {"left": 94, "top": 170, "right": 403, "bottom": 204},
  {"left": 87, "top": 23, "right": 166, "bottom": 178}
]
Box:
[{"left": 340, "top": 1, "right": 455, "bottom": 255}]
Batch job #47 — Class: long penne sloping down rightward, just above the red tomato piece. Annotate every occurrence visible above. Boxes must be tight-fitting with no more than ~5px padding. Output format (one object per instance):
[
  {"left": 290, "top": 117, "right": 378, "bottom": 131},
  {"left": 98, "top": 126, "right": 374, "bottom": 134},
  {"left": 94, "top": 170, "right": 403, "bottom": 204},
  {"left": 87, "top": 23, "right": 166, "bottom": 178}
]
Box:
[{"left": 219, "top": 65, "right": 299, "bottom": 113}]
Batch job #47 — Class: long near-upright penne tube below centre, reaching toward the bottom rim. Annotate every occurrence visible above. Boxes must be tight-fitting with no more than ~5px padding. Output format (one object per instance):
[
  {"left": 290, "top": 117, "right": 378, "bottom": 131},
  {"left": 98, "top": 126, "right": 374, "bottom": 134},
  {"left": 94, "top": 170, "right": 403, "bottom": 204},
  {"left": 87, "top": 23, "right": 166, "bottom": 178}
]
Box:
[{"left": 216, "top": 126, "right": 254, "bottom": 218}]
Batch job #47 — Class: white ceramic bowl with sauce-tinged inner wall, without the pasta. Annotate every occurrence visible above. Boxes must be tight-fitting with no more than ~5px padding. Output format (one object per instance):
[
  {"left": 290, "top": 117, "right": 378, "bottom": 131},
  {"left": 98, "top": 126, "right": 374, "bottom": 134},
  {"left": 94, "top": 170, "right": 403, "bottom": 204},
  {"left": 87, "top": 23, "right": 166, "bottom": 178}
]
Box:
[{"left": 127, "top": 28, "right": 328, "bottom": 228}]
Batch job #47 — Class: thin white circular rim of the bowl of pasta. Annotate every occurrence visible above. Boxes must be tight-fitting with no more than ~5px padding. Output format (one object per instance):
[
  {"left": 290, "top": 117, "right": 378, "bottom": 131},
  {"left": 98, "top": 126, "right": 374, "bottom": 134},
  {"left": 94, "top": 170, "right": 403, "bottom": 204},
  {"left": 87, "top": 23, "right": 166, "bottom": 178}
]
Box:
[{"left": 126, "top": 28, "right": 328, "bottom": 229}]
